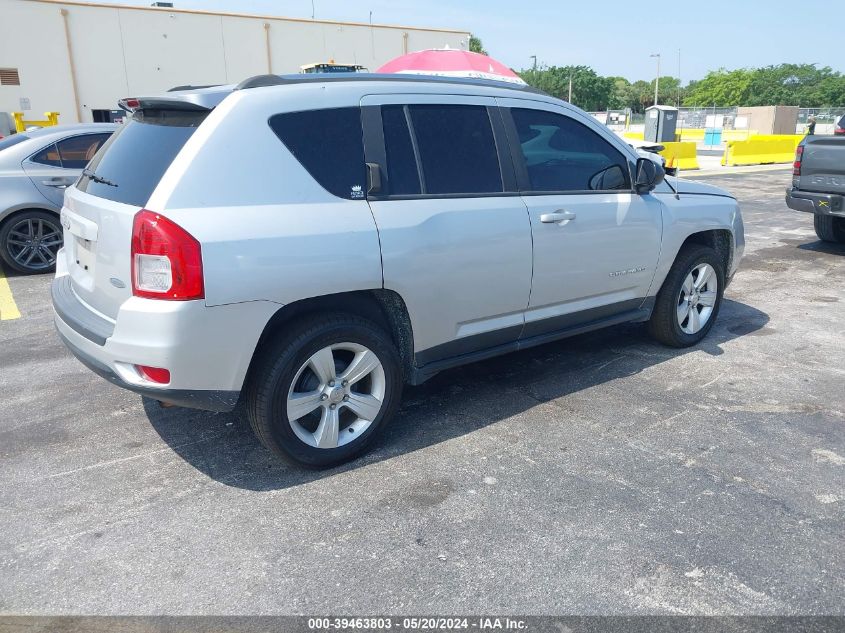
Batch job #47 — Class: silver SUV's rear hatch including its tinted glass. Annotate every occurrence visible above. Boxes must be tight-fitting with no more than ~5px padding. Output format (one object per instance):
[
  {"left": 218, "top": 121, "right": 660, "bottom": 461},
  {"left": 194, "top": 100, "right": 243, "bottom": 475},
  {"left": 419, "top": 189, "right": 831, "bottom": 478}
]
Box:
[{"left": 62, "top": 103, "right": 209, "bottom": 319}]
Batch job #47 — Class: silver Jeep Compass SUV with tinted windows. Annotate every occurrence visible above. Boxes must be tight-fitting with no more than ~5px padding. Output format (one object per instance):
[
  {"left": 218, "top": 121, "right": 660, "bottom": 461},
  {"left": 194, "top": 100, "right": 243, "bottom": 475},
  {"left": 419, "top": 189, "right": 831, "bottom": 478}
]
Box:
[{"left": 52, "top": 75, "right": 744, "bottom": 467}]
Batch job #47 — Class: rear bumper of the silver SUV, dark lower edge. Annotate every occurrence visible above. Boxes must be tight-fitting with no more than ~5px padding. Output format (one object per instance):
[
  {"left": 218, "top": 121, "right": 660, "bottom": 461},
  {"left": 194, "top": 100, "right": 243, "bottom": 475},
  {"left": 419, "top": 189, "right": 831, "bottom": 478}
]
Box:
[{"left": 52, "top": 274, "right": 279, "bottom": 411}]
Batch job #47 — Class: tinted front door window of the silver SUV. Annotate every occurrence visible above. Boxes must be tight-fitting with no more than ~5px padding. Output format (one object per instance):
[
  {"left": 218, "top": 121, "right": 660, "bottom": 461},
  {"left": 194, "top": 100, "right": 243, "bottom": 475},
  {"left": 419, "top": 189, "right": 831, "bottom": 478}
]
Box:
[{"left": 511, "top": 108, "right": 631, "bottom": 191}]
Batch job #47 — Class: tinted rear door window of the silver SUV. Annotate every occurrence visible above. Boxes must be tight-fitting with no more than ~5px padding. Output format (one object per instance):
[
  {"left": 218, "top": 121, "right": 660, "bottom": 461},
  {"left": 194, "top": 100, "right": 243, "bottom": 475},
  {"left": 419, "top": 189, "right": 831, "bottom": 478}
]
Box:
[{"left": 409, "top": 105, "right": 502, "bottom": 194}]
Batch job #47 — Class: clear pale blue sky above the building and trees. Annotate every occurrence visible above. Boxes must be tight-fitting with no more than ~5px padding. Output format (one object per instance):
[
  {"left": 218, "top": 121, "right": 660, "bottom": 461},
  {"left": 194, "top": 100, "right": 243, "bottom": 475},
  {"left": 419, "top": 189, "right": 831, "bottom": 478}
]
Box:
[{"left": 107, "top": 0, "right": 845, "bottom": 83}]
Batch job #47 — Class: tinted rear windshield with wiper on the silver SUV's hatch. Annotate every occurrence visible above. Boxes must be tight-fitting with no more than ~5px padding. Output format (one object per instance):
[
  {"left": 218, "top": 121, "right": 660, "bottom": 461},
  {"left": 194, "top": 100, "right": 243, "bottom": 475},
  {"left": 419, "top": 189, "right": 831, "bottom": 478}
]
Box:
[{"left": 77, "top": 110, "right": 208, "bottom": 207}]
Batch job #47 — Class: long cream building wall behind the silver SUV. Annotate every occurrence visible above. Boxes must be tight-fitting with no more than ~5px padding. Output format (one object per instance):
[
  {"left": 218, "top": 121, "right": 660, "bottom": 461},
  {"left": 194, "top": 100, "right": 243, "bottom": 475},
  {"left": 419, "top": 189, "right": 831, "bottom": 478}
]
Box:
[{"left": 0, "top": 0, "right": 469, "bottom": 123}]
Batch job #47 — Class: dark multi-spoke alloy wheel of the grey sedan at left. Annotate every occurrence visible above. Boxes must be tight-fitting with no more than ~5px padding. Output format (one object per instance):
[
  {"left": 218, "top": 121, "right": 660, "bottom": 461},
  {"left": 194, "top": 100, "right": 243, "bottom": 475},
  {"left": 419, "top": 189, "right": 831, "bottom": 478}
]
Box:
[{"left": 0, "top": 210, "right": 63, "bottom": 274}]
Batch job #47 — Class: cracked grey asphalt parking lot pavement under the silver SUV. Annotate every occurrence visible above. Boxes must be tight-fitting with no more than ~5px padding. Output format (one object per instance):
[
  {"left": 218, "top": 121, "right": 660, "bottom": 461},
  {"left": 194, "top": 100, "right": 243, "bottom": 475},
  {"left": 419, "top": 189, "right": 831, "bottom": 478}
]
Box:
[{"left": 0, "top": 171, "right": 845, "bottom": 614}]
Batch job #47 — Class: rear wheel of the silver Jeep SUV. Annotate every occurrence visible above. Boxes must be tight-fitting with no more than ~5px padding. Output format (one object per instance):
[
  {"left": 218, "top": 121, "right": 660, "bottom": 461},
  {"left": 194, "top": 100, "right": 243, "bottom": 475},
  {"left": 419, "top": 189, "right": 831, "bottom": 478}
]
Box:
[{"left": 246, "top": 314, "right": 402, "bottom": 468}]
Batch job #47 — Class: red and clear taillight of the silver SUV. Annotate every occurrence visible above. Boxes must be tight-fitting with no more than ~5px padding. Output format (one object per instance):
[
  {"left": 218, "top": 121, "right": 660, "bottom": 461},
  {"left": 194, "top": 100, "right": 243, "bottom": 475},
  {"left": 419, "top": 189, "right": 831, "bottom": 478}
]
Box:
[{"left": 132, "top": 209, "right": 205, "bottom": 301}]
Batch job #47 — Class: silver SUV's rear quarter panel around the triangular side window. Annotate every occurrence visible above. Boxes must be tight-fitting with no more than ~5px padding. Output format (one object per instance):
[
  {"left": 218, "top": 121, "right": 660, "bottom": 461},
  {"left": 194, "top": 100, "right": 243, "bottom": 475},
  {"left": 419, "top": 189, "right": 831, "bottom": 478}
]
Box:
[{"left": 147, "top": 87, "right": 382, "bottom": 305}]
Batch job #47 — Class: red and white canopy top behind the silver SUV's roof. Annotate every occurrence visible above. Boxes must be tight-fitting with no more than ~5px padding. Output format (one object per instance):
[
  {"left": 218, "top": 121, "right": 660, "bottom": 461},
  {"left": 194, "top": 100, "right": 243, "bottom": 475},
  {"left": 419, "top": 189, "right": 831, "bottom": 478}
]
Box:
[{"left": 376, "top": 48, "right": 525, "bottom": 84}]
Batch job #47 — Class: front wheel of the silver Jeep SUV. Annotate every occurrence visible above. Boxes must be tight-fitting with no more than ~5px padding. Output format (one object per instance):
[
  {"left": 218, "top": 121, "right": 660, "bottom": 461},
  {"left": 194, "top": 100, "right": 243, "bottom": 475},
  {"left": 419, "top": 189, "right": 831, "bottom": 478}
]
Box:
[{"left": 648, "top": 245, "right": 725, "bottom": 347}]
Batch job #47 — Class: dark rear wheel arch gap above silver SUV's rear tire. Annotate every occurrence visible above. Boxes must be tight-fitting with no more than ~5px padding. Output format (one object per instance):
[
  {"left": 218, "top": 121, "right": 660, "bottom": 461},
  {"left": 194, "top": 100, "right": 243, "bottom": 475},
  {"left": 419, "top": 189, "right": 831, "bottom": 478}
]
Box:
[{"left": 244, "top": 288, "right": 414, "bottom": 384}]
